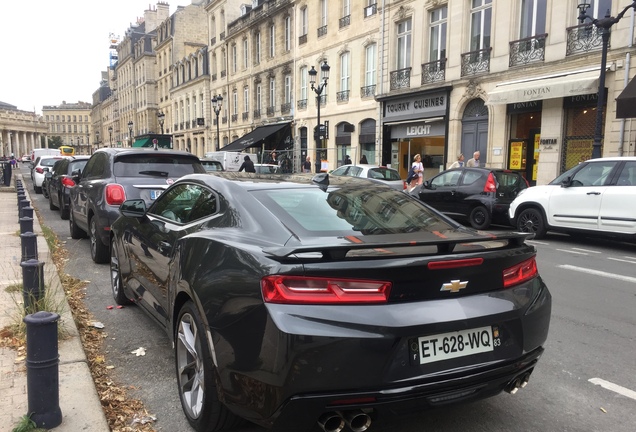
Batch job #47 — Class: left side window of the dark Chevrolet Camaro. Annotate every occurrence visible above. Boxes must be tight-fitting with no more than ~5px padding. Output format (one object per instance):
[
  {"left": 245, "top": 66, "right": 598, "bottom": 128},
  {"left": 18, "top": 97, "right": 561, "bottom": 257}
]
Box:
[{"left": 148, "top": 184, "right": 217, "bottom": 223}]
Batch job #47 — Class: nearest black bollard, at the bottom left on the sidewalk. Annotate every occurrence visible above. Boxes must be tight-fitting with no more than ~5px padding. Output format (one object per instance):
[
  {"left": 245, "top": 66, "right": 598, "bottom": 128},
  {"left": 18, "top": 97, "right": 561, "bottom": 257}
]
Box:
[{"left": 24, "top": 311, "right": 62, "bottom": 429}]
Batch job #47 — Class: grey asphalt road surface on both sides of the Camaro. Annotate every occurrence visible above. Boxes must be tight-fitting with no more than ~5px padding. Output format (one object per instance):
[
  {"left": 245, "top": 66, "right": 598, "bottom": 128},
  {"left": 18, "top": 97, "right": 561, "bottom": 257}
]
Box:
[{"left": 22, "top": 168, "right": 636, "bottom": 432}]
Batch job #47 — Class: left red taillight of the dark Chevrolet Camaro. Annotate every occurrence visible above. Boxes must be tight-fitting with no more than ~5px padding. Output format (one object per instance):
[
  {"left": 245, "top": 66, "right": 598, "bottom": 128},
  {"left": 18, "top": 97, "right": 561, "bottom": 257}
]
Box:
[{"left": 261, "top": 276, "right": 391, "bottom": 304}]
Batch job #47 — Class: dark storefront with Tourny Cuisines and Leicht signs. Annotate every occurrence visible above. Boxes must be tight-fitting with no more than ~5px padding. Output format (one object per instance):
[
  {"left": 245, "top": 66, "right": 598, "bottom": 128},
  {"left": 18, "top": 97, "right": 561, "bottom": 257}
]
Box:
[{"left": 382, "top": 88, "right": 450, "bottom": 178}]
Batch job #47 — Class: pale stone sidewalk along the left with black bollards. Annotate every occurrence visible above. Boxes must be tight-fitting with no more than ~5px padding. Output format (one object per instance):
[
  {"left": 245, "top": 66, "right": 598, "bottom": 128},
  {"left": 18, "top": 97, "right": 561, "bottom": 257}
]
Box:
[{"left": 0, "top": 174, "right": 110, "bottom": 432}]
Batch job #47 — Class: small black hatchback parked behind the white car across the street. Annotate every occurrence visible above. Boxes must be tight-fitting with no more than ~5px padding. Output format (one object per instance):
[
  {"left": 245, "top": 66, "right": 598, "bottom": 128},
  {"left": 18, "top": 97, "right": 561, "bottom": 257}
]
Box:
[{"left": 411, "top": 168, "right": 528, "bottom": 229}]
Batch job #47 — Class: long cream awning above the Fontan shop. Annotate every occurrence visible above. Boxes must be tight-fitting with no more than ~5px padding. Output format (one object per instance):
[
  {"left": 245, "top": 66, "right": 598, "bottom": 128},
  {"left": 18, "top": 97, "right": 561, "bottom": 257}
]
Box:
[{"left": 486, "top": 70, "right": 599, "bottom": 105}]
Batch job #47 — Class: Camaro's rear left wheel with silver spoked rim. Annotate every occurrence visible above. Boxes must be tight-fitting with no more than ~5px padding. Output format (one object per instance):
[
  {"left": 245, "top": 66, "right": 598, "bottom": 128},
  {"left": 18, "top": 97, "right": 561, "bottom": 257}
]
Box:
[{"left": 174, "top": 301, "right": 242, "bottom": 432}]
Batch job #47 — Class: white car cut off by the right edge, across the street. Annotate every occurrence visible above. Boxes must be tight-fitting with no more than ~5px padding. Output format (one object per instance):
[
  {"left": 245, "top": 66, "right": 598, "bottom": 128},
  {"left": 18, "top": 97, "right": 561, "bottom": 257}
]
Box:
[{"left": 509, "top": 157, "right": 636, "bottom": 238}]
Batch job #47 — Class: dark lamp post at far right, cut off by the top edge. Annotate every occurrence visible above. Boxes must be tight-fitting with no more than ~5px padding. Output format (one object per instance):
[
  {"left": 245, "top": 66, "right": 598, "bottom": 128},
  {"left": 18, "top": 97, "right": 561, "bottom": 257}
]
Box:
[{"left": 577, "top": 1, "right": 636, "bottom": 159}]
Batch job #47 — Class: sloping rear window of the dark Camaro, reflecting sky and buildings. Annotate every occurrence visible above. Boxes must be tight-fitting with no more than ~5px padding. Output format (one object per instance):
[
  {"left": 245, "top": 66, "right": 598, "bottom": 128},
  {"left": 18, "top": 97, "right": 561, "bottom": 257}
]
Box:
[{"left": 253, "top": 188, "right": 453, "bottom": 236}]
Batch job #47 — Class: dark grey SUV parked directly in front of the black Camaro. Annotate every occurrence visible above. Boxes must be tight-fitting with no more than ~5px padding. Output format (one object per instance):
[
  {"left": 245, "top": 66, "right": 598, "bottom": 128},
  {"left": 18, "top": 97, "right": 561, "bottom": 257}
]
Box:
[{"left": 69, "top": 148, "right": 206, "bottom": 263}]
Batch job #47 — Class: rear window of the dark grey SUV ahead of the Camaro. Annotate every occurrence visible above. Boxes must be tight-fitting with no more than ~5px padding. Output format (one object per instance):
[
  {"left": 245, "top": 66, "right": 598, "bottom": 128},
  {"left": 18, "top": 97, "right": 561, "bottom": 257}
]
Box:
[{"left": 113, "top": 154, "right": 205, "bottom": 177}]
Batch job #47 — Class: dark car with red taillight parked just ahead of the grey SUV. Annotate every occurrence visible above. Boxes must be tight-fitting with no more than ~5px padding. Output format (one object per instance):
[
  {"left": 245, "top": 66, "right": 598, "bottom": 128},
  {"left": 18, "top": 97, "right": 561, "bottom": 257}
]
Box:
[{"left": 42, "top": 156, "right": 90, "bottom": 219}]
